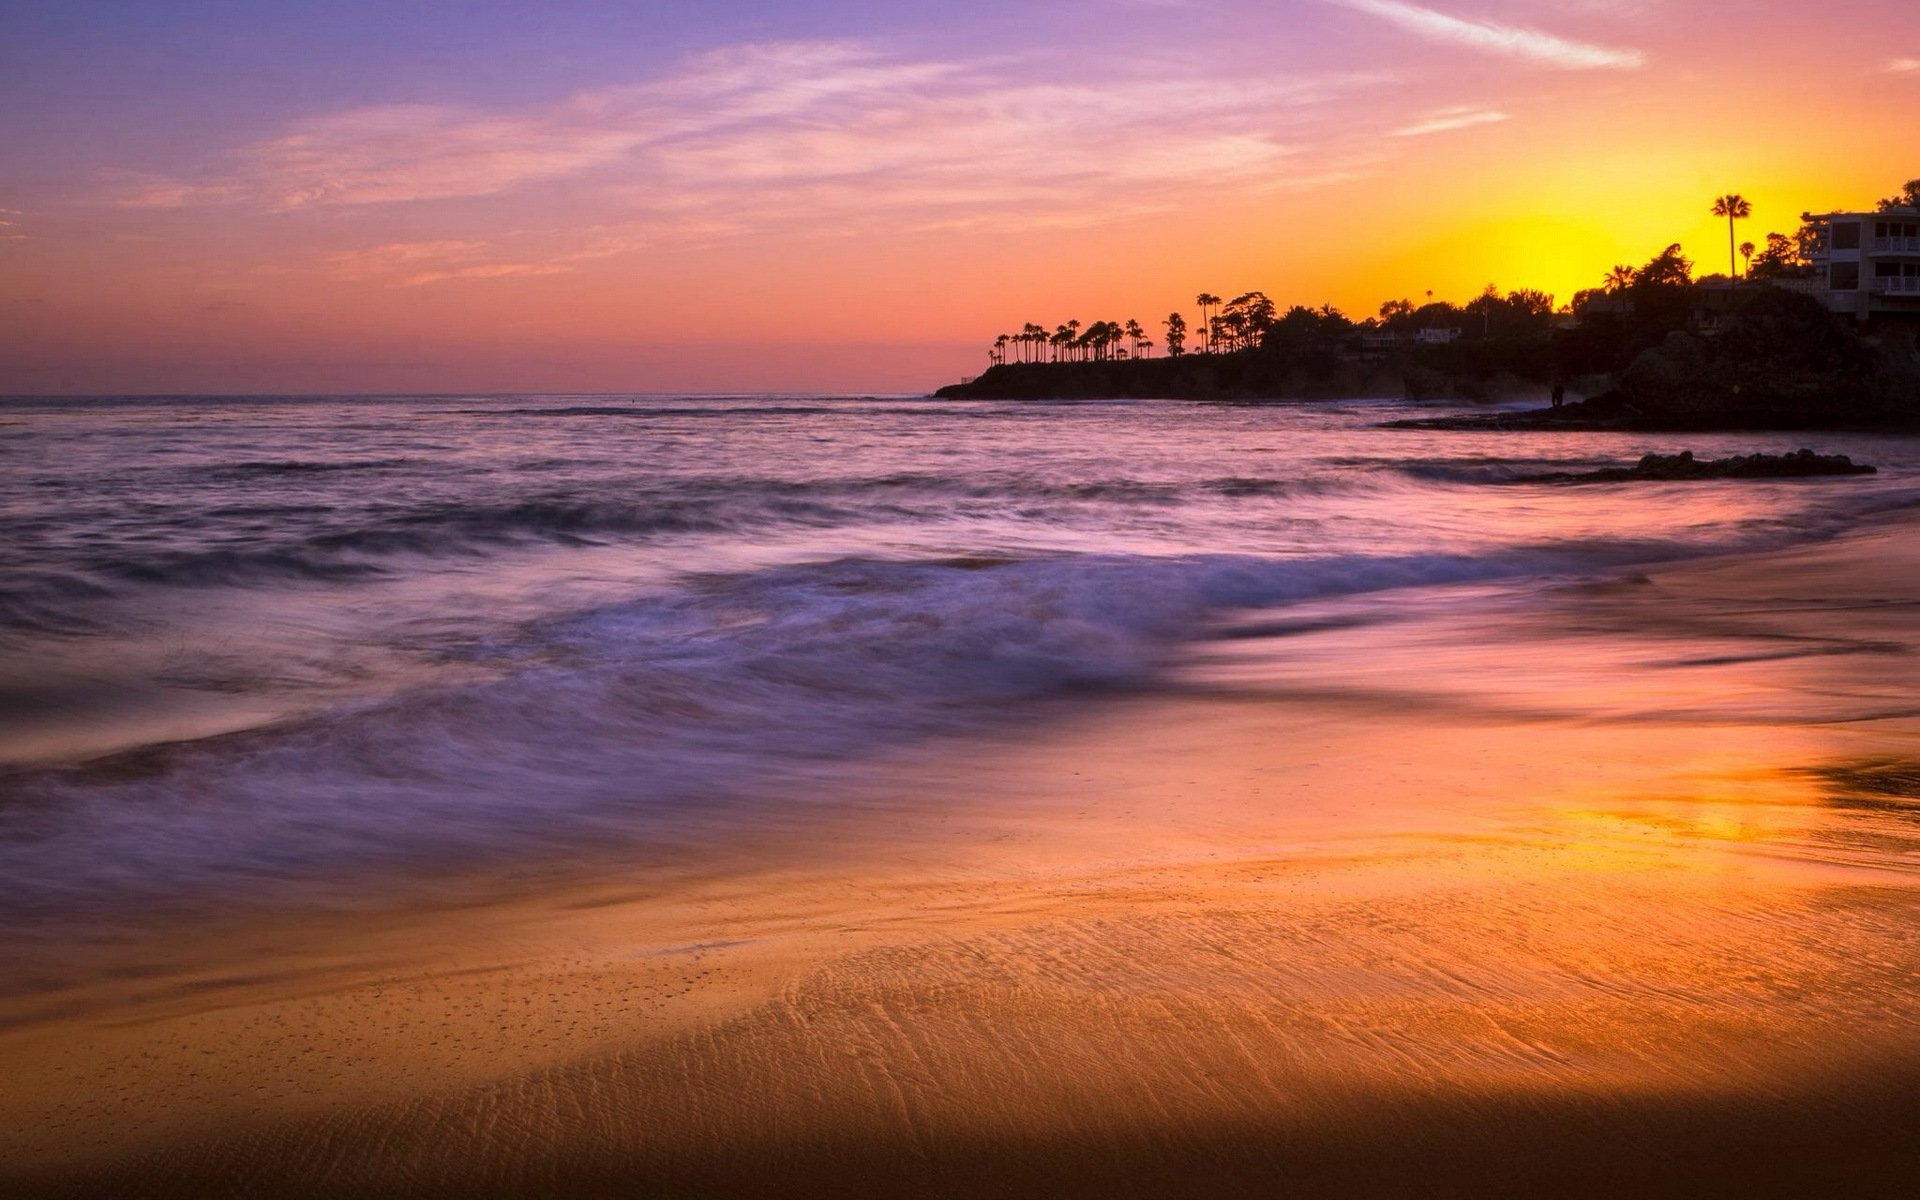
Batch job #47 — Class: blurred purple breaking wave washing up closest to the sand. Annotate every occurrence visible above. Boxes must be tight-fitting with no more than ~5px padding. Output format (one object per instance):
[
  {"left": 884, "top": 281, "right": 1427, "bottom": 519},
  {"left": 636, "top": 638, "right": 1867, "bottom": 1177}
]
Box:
[{"left": 0, "top": 545, "right": 1645, "bottom": 920}]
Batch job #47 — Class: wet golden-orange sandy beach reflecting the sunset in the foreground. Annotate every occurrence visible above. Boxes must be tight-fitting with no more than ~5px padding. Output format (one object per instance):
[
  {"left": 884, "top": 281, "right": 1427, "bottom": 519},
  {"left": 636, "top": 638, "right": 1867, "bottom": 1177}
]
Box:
[{"left": 0, "top": 526, "right": 1920, "bottom": 1196}]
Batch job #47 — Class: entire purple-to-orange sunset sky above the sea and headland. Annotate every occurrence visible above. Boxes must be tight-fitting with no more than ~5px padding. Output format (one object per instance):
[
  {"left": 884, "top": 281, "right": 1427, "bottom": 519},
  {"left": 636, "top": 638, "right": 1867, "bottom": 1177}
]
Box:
[{"left": 0, "top": 0, "right": 1920, "bottom": 394}]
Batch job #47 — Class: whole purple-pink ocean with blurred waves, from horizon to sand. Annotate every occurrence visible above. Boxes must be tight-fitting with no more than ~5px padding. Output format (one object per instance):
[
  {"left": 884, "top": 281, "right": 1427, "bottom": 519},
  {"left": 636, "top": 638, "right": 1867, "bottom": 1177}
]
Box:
[{"left": 0, "top": 396, "right": 1920, "bottom": 925}]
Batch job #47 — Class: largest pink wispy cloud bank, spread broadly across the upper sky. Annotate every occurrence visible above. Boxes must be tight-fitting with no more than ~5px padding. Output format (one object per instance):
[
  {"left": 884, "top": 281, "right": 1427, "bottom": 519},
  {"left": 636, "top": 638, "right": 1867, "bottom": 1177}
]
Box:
[{"left": 108, "top": 42, "right": 1359, "bottom": 215}]
